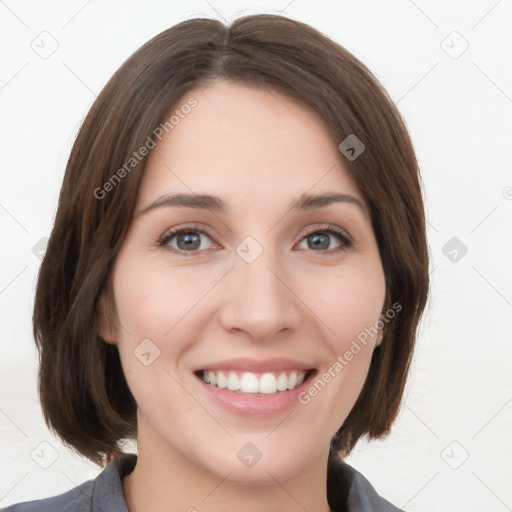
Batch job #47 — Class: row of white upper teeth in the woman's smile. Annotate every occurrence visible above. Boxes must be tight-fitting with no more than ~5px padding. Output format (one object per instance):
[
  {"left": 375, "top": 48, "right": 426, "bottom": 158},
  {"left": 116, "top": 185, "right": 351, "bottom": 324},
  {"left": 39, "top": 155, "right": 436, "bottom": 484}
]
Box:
[{"left": 203, "top": 370, "right": 306, "bottom": 393}]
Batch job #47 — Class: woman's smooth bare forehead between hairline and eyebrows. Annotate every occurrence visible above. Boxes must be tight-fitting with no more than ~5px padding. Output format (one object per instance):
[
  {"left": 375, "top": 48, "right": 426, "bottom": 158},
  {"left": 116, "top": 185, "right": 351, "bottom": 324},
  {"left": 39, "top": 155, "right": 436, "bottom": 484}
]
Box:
[{"left": 139, "top": 81, "right": 364, "bottom": 208}]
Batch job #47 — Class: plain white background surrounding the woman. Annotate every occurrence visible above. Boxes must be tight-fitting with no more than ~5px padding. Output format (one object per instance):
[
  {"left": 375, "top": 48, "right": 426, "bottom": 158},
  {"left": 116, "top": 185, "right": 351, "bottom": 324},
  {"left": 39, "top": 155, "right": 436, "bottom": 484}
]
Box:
[{"left": 0, "top": 0, "right": 512, "bottom": 512}]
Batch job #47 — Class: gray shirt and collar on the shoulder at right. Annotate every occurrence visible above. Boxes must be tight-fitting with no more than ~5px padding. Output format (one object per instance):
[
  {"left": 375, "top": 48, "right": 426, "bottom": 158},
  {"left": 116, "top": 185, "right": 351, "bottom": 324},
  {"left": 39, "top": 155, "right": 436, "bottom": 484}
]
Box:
[{"left": 328, "top": 459, "right": 405, "bottom": 512}]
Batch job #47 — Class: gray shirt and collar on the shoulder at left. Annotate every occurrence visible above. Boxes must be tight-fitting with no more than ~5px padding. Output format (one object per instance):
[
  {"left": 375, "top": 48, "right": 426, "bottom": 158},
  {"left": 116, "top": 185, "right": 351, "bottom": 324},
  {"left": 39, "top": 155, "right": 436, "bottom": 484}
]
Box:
[{"left": 0, "top": 453, "right": 137, "bottom": 512}]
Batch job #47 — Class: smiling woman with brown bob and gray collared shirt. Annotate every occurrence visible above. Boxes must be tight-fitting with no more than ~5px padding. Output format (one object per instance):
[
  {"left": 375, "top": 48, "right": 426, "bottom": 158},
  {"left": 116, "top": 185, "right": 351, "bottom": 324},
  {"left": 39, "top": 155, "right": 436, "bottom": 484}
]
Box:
[{"left": 5, "top": 15, "right": 428, "bottom": 512}]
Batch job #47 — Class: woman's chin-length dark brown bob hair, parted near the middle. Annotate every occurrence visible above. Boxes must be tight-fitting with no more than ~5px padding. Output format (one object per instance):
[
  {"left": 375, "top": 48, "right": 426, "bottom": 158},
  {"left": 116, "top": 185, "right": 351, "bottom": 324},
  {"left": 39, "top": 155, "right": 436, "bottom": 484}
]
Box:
[{"left": 33, "top": 14, "right": 429, "bottom": 466}]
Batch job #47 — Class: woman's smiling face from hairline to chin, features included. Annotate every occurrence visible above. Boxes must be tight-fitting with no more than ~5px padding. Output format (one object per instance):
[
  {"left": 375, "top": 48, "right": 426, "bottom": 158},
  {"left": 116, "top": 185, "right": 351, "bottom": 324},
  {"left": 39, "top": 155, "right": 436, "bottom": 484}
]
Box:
[{"left": 100, "top": 81, "right": 385, "bottom": 483}]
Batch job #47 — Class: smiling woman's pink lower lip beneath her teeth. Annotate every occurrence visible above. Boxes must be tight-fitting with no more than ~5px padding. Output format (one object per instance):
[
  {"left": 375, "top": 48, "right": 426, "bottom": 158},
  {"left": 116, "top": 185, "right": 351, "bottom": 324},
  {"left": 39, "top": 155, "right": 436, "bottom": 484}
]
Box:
[{"left": 195, "top": 371, "right": 316, "bottom": 417}]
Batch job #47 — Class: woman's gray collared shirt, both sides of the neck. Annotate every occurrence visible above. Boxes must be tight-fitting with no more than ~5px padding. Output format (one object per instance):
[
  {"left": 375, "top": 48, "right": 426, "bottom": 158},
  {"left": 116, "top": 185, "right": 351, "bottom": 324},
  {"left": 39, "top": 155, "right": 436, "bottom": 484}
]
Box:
[{"left": 0, "top": 453, "right": 401, "bottom": 512}]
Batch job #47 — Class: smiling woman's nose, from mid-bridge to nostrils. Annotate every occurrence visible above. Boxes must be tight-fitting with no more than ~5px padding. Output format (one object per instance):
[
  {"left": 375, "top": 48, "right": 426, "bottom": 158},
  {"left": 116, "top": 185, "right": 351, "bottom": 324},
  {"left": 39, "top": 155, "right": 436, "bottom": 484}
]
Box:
[{"left": 220, "top": 246, "right": 304, "bottom": 341}]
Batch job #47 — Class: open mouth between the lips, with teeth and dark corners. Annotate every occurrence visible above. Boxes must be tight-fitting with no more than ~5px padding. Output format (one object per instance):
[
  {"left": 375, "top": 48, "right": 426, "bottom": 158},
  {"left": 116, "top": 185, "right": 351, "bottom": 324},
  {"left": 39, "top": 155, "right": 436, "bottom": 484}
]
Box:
[{"left": 194, "top": 368, "right": 316, "bottom": 397}]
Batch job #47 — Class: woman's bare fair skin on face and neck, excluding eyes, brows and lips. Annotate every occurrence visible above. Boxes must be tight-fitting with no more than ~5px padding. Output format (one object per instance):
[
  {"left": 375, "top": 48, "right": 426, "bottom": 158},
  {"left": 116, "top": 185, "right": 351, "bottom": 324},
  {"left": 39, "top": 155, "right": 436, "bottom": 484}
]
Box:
[{"left": 100, "top": 81, "right": 385, "bottom": 512}]
